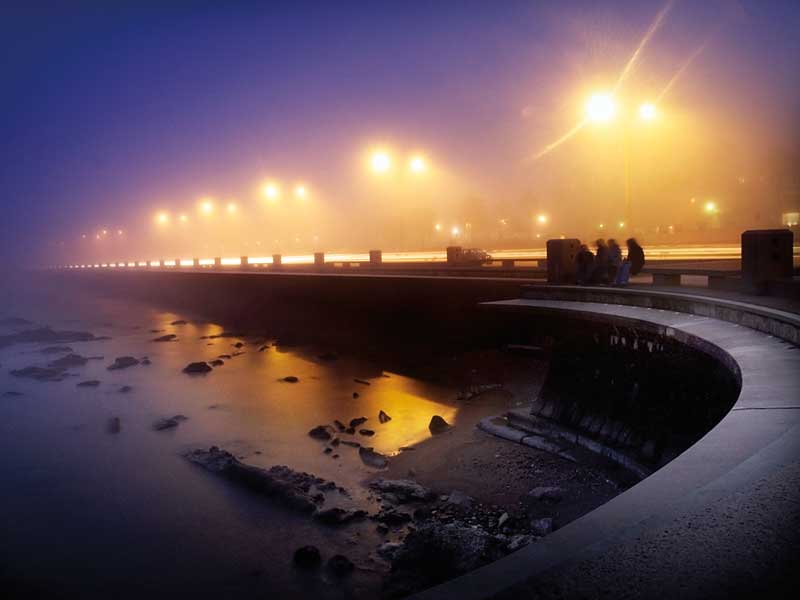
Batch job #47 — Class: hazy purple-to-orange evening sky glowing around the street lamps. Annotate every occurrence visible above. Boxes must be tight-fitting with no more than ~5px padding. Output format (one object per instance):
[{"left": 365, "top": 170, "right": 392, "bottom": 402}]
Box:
[{"left": 0, "top": 0, "right": 800, "bottom": 264}]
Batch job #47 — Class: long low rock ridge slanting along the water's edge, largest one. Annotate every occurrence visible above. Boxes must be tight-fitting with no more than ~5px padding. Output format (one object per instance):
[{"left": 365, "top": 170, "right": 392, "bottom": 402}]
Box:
[{"left": 185, "top": 446, "right": 334, "bottom": 513}]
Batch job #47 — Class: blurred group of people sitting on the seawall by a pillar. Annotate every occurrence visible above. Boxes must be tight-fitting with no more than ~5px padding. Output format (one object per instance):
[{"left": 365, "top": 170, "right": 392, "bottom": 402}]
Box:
[{"left": 575, "top": 238, "right": 644, "bottom": 286}]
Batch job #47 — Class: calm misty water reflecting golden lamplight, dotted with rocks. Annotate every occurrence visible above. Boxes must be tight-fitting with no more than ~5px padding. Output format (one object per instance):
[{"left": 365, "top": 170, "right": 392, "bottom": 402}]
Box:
[{"left": 0, "top": 278, "right": 457, "bottom": 598}]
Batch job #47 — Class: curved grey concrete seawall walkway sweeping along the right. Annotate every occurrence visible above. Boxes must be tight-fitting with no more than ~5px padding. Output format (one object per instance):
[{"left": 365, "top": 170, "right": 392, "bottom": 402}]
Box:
[{"left": 415, "top": 286, "right": 800, "bottom": 600}]
